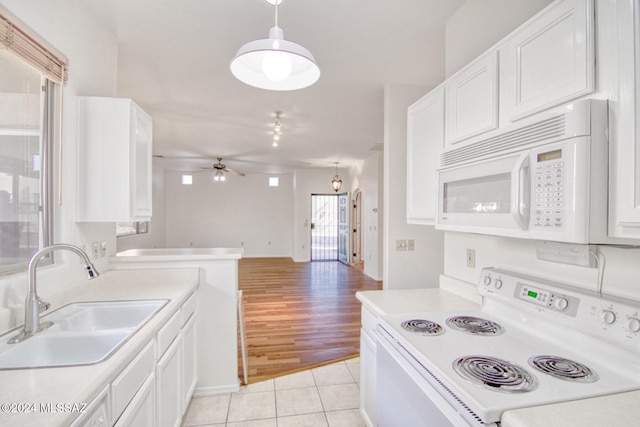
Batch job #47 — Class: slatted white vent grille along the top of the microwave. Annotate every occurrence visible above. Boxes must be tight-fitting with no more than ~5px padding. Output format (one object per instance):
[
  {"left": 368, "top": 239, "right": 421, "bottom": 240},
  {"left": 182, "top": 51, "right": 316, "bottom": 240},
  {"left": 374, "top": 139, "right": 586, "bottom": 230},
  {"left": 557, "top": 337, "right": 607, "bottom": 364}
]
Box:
[{"left": 440, "top": 114, "right": 568, "bottom": 168}]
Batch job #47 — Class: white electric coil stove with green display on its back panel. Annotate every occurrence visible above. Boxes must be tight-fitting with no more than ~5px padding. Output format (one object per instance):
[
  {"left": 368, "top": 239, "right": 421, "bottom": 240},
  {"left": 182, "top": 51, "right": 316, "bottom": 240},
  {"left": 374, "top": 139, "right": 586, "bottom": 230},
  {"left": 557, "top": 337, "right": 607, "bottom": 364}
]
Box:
[{"left": 376, "top": 269, "right": 640, "bottom": 427}]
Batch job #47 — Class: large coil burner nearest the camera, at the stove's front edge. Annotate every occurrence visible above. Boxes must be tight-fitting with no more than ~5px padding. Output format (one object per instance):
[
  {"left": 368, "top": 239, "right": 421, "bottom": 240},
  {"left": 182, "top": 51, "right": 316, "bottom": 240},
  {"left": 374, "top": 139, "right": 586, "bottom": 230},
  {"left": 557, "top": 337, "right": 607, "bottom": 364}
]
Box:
[{"left": 453, "top": 356, "right": 538, "bottom": 393}]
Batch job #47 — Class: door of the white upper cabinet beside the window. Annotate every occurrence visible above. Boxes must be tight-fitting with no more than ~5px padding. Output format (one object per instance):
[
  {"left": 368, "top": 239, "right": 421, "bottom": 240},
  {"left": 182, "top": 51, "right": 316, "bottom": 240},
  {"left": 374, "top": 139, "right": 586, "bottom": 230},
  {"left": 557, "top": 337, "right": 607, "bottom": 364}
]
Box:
[{"left": 131, "top": 104, "right": 153, "bottom": 221}]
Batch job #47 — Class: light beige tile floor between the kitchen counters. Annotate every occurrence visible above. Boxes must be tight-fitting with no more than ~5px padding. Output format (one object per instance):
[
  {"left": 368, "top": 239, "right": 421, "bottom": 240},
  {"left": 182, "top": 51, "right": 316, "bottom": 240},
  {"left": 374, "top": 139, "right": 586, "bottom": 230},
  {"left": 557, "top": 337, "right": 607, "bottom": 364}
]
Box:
[{"left": 183, "top": 358, "right": 364, "bottom": 427}]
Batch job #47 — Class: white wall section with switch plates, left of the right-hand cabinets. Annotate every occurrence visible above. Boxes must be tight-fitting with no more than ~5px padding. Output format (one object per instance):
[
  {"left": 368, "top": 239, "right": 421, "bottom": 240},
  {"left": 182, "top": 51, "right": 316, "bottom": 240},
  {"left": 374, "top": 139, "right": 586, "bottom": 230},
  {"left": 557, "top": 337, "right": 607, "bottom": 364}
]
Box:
[{"left": 383, "top": 85, "right": 443, "bottom": 289}]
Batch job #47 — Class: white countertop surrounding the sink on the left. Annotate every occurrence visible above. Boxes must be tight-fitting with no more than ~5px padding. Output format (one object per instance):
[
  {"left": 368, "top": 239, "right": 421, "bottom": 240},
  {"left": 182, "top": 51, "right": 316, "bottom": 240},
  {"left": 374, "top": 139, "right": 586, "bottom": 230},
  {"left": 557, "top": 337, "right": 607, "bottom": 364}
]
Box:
[{"left": 0, "top": 268, "right": 198, "bottom": 427}]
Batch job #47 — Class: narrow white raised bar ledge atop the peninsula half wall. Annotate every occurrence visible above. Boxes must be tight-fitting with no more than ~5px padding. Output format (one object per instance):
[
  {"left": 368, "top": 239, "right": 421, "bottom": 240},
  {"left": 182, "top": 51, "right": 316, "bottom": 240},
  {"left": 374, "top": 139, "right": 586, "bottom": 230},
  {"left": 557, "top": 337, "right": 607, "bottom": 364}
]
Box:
[{"left": 109, "top": 248, "right": 244, "bottom": 262}]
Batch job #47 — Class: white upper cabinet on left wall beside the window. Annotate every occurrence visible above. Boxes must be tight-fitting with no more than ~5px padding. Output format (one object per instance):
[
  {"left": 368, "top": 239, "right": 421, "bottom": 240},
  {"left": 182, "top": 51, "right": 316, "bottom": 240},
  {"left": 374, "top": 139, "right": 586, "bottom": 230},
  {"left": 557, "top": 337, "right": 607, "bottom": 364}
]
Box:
[{"left": 78, "top": 97, "right": 153, "bottom": 222}]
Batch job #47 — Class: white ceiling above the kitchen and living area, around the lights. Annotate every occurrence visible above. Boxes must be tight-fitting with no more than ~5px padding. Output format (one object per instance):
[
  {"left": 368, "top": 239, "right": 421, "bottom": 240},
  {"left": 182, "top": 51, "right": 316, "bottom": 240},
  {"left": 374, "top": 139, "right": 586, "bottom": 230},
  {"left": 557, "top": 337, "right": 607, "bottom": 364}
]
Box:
[{"left": 83, "top": 0, "right": 464, "bottom": 173}]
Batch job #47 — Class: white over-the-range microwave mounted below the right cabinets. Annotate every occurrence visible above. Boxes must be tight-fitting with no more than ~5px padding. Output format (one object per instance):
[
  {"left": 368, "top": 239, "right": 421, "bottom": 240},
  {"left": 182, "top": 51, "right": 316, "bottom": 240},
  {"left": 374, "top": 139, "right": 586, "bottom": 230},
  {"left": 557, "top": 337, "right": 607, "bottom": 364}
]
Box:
[{"left": 436, "top": 100, "right": 608, "bottom": 243}]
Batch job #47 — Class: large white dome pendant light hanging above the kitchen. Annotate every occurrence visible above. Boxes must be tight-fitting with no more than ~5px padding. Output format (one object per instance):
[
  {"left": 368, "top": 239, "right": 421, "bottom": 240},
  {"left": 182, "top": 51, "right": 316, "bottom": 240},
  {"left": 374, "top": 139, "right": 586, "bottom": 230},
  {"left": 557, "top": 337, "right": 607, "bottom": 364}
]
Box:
[{"left": 230, "top": 0, "right": 320, "bottom": 90}]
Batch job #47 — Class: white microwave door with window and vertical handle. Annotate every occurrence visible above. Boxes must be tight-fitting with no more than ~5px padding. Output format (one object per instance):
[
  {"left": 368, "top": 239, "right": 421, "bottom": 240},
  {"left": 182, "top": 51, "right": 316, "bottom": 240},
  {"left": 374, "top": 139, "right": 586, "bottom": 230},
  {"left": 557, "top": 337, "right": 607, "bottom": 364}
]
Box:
[{"left": 436, "top": 152, "right": 530, "bottom": 237}]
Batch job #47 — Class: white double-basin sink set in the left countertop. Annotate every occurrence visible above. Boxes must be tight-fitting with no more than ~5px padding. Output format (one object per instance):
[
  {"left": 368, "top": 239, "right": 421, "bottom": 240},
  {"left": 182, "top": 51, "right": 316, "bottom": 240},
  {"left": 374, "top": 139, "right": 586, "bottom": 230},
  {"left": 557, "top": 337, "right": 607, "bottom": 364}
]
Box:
[{"left": 0, "top": 300, "right": 168, "bottom": 369}]
